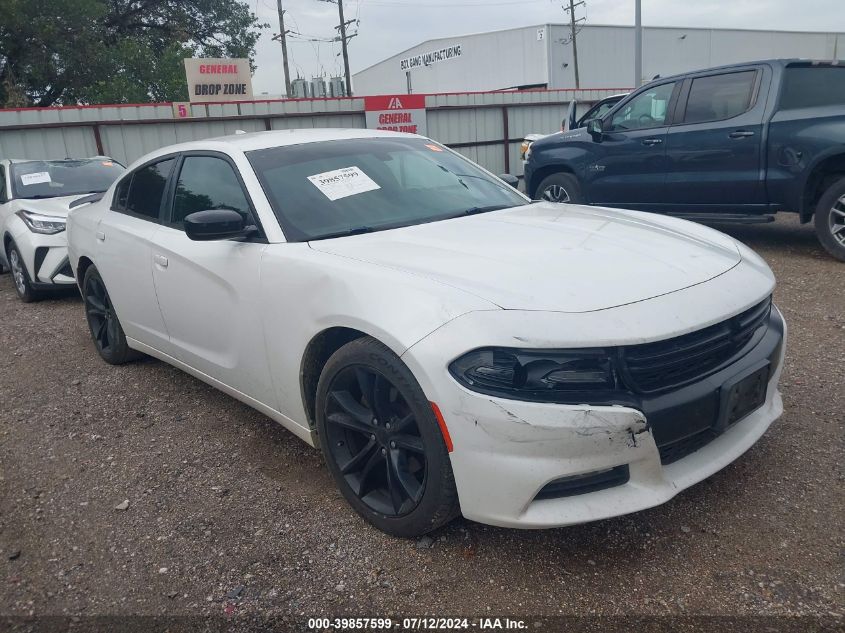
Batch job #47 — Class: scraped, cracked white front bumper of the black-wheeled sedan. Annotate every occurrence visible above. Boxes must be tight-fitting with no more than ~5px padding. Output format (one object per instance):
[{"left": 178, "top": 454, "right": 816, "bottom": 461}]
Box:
[{"left": 403, "top": 266, "right": 786, "bottom": 528}]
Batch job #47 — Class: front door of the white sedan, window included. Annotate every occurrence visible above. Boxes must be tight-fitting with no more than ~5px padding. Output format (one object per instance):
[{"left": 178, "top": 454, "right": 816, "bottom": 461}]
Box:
[{"left": 148, "top": 154, "right": 278, "bottom": 409}]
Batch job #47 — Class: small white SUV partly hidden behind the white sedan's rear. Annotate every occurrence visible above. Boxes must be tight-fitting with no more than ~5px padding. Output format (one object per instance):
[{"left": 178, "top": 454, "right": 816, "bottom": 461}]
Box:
[{"left": 0, "top": 156, "right": 124, "bottom": 302}]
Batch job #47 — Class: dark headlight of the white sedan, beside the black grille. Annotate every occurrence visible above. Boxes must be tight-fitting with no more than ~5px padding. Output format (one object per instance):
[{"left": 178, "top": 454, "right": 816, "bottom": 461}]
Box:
[{"left": 449, "top": 347, "right": 617, "bottom": 403}]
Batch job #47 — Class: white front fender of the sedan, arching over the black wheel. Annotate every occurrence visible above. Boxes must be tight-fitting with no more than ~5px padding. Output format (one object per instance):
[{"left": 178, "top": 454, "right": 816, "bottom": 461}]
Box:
[{"left": 261, "top": 244, "right": 499, "bottom": 428}]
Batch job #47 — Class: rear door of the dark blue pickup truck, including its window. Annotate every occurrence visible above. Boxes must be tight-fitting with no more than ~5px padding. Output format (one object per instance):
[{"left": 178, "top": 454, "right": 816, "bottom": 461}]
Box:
[{"left": 661, "top": 67, "right": 771, "bottom": 212}]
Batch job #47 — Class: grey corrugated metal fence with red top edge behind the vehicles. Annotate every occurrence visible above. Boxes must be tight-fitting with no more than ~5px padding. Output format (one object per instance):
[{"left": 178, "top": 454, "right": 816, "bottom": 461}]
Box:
[{"left": 0, "top": 90, "right": 613, "bottom": 175}]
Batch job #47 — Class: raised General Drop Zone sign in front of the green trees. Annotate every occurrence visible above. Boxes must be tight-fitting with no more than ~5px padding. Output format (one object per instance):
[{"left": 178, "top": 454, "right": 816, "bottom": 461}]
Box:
[{"left": 185, "top": 58, "right": 252, "bottom": 103}]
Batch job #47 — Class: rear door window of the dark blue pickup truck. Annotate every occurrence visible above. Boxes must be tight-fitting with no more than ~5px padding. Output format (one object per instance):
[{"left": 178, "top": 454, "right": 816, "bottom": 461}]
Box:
[{"left": 684, "top": 70, "right": 757, "bottom": 123}]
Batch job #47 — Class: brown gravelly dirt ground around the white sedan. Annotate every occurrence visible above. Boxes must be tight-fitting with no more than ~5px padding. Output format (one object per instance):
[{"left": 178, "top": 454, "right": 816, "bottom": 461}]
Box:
[{"left": 0, "top": 218, "right": 845, "bottom": 623}]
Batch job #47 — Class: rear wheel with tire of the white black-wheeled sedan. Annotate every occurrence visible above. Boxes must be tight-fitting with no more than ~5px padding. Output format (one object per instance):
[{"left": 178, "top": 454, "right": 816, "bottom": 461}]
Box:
[{"left": 82, "top": 266, "right": 141, "bottom": 365}]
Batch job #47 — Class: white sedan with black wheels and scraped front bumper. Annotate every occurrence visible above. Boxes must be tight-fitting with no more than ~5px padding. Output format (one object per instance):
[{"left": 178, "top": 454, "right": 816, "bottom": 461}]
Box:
[{"left": 68, "top": 130, "right": 785, "bottom": 536}]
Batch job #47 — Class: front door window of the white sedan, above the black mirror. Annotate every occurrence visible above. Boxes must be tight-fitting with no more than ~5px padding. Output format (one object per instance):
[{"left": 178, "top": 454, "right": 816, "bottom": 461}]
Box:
[{"left": 170, "top": 156, "right": 255, "bottom": 226}]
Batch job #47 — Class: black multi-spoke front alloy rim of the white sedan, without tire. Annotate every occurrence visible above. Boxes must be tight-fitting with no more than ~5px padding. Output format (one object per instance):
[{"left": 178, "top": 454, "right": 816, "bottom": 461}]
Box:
[{"left": 325, "top": 365, "right": 427, "bottom": 517}]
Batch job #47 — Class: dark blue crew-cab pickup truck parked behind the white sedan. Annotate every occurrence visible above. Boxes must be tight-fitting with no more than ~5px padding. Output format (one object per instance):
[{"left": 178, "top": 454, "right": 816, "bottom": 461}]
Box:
[{"left": 525, "top": 60, "right": 845, "bottom": 261}]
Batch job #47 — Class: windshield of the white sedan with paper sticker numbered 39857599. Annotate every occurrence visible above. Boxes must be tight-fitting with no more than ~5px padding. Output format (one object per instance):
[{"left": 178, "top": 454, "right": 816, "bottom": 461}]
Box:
[{"left": 247, "top": 137, "right": 528, "bottom": 242}]
